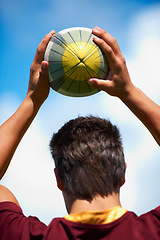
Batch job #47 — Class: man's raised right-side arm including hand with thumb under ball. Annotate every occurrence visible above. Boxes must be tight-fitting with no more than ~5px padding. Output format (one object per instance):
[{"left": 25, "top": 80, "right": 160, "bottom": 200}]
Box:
[{"left": 88, "top": 27, "right": 160, "bottom": 145}]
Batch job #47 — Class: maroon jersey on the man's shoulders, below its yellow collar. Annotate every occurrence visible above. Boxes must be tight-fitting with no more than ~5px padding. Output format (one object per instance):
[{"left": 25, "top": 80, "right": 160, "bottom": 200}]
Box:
[{"left": 0, "top": 202, "right": 160, "bottom": 240}]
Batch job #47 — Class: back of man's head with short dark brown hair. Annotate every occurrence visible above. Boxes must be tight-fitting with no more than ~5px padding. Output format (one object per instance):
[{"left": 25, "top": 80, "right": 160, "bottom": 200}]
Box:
[{"left": 50, "top": 116, "right": 125, "bottom": 201}]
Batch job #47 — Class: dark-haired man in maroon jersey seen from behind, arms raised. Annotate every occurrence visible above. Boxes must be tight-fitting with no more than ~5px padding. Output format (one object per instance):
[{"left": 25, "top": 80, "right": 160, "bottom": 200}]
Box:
[{"left": 0, "top": 27, "right": 160, "bottom": 240}]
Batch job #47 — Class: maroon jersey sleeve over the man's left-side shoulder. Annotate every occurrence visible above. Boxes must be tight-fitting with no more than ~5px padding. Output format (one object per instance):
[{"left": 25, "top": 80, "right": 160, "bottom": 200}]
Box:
[{"left": 0, "top": 202, "right": 46, "bottom": 240}]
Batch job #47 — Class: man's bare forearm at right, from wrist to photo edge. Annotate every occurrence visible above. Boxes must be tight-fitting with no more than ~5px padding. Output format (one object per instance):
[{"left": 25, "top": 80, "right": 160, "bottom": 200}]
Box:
[{"left": 121, "top": 86, "right": 160, "bottom": 145}]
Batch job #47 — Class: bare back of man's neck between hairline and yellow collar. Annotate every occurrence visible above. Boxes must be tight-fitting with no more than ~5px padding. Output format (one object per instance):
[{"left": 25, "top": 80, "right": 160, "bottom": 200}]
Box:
[{"left": 69, "top": 193, "right": 121, "bottom": 214}]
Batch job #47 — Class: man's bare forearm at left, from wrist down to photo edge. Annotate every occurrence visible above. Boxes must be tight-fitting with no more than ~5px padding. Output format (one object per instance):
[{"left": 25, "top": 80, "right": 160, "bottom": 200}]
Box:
[{"left": 0, "top": 96, "right": 40, "bottom": 179}]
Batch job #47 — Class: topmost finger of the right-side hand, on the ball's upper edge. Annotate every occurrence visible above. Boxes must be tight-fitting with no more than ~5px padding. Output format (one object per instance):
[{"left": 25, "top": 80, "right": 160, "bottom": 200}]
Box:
[{"left": 92, "top": 27, "right": 122, "bottom": 56}]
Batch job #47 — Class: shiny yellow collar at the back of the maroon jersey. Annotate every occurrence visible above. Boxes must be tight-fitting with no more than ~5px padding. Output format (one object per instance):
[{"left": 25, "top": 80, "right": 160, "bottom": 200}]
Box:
[{"left": 64, "top": 207, "right": 127, "bottom": 224}]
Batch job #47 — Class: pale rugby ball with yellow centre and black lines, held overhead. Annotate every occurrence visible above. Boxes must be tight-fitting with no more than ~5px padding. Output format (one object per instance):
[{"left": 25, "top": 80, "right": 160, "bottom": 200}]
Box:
[{"left": 45, "top": 27, "right": 109, "bottom": 97}]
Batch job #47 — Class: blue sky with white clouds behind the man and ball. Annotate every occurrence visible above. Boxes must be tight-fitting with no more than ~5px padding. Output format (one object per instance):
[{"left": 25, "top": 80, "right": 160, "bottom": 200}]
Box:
[{"left": 0, "top": 0, "right": 160, "bottom": 223}]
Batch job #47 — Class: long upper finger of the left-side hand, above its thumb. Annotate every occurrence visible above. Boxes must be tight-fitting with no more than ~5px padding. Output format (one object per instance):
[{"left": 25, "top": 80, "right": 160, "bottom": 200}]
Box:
[{"left": 34, "top": 30, "right": 55, "bottom": 64}]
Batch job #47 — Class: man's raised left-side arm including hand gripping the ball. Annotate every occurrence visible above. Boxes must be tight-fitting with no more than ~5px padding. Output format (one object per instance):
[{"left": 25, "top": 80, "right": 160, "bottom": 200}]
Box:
[{"left": 0, "top": 31, "right": 55, "bottom": 179}]
